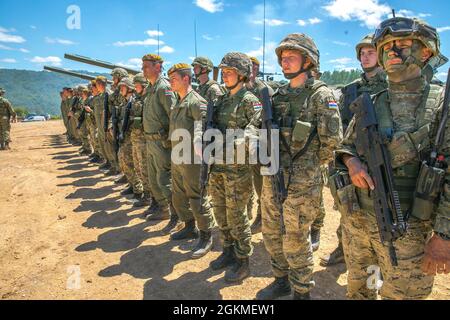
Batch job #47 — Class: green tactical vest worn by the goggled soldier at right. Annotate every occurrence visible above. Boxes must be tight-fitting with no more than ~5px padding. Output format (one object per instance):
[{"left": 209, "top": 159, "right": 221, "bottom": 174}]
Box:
[{"left": 356, "top": 79, "right": 443, "bottom": 212}]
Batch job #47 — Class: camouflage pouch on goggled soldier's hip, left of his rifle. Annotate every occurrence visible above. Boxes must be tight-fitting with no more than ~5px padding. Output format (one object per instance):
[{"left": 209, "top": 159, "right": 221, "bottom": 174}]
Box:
[{"left": 329, "top": 171, "right": 361, "bottom": 215}]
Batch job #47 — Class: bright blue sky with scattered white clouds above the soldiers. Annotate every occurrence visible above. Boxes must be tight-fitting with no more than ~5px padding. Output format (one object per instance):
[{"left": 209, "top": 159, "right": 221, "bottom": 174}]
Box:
[{"left": 0, "top": 0, "right": 450, "bottom": 79}]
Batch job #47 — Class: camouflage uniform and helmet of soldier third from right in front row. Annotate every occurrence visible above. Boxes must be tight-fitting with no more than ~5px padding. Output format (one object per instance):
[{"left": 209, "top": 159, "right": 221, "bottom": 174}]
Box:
[{"left": 209, "top": 53, "right": 261, "bottom": 259}]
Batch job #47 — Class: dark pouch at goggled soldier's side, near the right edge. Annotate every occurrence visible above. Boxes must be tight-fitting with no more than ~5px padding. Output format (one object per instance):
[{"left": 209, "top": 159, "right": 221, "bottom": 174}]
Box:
[{"left": 411, "top": 161, "right": 445, "bottom": 220}]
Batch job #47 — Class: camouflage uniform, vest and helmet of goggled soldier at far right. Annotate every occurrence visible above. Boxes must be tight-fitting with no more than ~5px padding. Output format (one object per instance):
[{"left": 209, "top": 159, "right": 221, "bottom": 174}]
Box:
[{"left": 336, "top": 18, "right": 450, "bottom": 299}]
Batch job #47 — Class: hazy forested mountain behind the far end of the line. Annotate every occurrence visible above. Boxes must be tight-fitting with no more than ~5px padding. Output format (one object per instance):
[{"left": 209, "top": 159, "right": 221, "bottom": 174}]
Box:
[{"left": 0, "top": 69, "right": 110, "bottom": 115}]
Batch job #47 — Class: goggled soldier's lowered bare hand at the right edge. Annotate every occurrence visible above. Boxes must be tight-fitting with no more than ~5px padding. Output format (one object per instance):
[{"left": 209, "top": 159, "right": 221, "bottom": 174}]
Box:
[{"left": 422, "top": 234, "right": 450, "bottom": 276}]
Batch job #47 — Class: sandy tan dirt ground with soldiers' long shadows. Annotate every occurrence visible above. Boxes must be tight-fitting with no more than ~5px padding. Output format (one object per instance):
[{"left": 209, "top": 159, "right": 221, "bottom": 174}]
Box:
[{"left": 0, "top": 121, "right": 450, "bottom": 300}]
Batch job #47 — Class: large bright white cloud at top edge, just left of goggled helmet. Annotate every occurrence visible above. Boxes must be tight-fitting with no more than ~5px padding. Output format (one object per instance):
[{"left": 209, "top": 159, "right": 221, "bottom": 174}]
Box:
[{"left": 323, "top": 0, "right": 391, "bottom": 29}]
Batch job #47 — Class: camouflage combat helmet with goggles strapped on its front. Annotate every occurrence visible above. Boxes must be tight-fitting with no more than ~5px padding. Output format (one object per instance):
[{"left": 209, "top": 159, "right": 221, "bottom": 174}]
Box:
[{"left": 373, "top": 17, "right": 440, "bottom": 65}]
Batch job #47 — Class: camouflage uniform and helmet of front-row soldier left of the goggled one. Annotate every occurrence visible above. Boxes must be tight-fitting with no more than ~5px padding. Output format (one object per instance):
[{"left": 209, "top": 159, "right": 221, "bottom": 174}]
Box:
[{"left": 261, "top": 34, "right": 342, "bottom": 294}]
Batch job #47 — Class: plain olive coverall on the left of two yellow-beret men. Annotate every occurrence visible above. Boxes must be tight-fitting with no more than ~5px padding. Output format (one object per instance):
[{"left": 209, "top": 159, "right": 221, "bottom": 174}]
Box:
[{"left": 143, "top": 56, "right": 176, "bottom": 208}]
